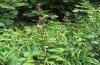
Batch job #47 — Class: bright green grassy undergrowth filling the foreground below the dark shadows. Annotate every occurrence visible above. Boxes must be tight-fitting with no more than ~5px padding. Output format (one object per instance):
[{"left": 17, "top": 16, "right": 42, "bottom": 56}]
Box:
[{"left": 0, "top": 21, "right": 100, "bottom": 65}]
